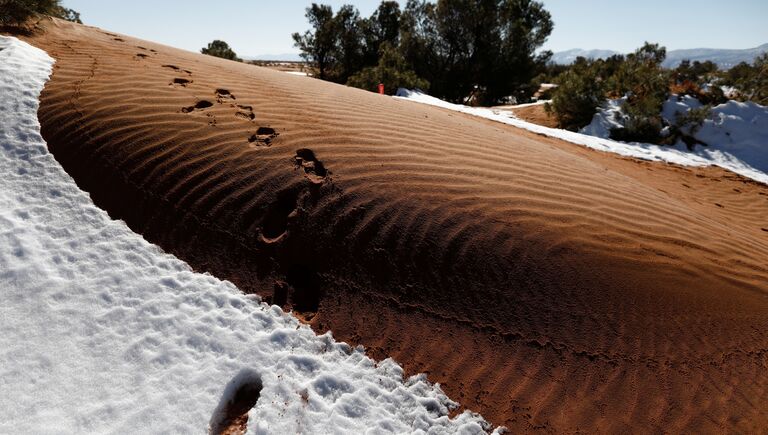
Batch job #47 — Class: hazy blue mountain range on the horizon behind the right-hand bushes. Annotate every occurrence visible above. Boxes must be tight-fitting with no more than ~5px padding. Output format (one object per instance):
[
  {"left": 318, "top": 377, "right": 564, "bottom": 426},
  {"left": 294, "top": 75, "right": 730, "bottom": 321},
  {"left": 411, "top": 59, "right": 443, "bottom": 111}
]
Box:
[{"left": 552, "top": 44, "right": 768, "bottom": 69}]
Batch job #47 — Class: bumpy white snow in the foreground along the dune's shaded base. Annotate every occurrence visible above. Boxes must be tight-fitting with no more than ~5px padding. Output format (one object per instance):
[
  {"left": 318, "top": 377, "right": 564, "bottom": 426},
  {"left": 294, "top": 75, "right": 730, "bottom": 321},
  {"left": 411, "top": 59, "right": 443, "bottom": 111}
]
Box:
[{"left": 0, "top": 36, "right": 498, "bottom": 433}]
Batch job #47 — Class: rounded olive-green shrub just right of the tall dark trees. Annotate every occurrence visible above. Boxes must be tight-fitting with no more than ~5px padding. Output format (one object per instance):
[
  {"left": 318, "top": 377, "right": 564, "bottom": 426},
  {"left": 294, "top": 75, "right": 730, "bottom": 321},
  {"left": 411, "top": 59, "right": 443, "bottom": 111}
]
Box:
[{"left": 546, "top": 61, "right": 605, "bottom": 131}]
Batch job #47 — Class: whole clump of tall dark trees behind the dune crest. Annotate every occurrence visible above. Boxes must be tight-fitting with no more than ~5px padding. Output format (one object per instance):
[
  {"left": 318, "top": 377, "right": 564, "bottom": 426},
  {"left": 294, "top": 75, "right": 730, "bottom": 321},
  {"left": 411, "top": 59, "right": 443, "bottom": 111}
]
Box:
[{"left": 293, "top": 0, "right": 553, "bottom": 103}]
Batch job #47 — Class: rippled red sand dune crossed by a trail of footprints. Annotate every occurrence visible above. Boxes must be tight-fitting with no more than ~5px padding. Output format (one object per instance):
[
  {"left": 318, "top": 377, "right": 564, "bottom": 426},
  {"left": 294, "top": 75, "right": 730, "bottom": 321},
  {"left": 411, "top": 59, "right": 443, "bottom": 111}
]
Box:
[{"left": 10, "top": 20, "right": 768, "bottom": 433}]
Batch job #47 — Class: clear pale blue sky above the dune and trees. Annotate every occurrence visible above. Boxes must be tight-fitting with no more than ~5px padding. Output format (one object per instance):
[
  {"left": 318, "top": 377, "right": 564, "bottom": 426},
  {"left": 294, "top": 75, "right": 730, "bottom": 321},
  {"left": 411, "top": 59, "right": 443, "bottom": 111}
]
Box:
[{"left": 62, "top": 0, "right": 768, "bottom": 56}]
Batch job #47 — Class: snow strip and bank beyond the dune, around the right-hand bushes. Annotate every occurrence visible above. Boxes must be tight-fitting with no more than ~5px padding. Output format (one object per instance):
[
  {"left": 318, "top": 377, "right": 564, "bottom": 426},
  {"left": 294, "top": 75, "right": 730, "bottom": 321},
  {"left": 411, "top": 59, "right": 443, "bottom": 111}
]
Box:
[{"left": 397, "top": 89, "right": 768, "bottom": 184}]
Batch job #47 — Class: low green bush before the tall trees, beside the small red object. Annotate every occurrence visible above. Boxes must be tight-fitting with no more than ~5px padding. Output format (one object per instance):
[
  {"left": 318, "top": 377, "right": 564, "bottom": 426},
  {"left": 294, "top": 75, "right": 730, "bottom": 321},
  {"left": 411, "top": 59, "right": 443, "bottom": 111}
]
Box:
[{"left": 347, "top": 42, "right": 429, "bottom": 95}]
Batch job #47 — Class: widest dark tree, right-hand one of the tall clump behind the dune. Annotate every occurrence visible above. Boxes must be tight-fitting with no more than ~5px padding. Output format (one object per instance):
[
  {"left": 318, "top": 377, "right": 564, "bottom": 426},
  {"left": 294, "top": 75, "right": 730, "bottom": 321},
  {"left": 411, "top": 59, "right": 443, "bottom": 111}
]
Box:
[{"left": 416, "top": 0, "right": 553, "bottom": 104}]
